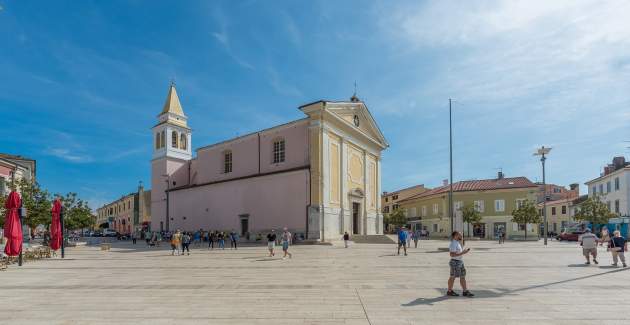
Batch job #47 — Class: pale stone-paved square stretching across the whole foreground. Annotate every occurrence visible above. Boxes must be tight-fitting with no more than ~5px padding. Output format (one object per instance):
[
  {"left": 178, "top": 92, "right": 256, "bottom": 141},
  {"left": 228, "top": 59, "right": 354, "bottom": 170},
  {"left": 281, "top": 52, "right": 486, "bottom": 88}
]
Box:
[{"left": 0, "top": 241, "right": 630, "bottom": 325}]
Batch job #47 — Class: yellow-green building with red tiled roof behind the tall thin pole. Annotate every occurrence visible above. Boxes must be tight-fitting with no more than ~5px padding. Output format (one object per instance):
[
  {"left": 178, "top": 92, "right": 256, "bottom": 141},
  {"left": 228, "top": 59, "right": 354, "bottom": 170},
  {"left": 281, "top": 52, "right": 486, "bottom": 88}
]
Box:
[{"left": 399, "top": 173, "right": 538, "bottom": 239}]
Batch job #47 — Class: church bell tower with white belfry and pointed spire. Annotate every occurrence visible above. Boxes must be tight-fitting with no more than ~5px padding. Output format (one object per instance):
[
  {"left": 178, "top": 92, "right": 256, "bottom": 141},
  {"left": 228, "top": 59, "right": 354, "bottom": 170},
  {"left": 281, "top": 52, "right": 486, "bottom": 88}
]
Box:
[{"left": 151, "top": 82, "right": 192, "bottom": 231}]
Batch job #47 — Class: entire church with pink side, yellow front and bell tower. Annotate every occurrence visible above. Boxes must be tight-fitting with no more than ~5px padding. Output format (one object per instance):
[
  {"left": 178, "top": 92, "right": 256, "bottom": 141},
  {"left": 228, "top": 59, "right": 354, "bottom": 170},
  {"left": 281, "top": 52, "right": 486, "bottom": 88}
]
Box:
[{"left": 151, "top": 85, "right": 388, "bottom": 241}]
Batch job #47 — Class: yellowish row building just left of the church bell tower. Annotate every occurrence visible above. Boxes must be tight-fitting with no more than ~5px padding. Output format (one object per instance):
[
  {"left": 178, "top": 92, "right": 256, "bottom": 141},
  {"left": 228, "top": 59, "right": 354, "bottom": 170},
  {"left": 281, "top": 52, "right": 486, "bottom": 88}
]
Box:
[{"left": 95, "top": 183, "right": 151, "bottom": 234}]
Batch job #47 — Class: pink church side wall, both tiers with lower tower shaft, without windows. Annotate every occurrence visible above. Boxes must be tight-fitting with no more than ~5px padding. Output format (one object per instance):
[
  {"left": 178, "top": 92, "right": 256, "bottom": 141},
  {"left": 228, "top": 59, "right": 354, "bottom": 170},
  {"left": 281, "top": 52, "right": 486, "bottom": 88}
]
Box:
[{"left": 151, "top": 119, "right": 310, "bottom": 231}]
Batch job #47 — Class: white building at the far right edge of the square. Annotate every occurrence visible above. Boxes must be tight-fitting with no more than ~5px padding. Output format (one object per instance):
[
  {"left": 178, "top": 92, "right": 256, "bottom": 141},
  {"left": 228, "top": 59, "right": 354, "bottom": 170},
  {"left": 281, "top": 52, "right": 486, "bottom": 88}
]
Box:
[{"left": 585, "top": 157, "right": 630, "bottom": 217}]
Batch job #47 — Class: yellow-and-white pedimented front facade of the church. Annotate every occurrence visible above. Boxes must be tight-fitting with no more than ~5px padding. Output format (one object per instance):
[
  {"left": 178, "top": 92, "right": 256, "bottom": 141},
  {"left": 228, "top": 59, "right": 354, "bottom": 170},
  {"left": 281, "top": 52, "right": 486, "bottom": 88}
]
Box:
[{"left": 300, "top": 97, "right": 388, "bottom": 240}]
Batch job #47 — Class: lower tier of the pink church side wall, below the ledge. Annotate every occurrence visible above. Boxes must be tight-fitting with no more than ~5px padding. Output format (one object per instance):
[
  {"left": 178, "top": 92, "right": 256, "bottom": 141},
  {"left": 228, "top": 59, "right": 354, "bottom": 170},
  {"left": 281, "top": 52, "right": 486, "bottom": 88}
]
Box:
[{"left": 165, "top": 169, "right": 309, "bottom": 235}]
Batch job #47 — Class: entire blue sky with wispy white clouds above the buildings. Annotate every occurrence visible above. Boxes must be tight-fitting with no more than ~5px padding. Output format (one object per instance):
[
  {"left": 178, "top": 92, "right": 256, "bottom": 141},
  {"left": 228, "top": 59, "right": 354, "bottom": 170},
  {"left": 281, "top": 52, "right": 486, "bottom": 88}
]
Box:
[{"left": 0, "top": 0, "right": 630, "bottom": 207}]
